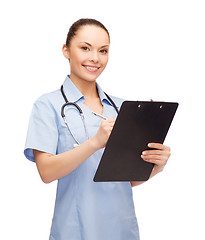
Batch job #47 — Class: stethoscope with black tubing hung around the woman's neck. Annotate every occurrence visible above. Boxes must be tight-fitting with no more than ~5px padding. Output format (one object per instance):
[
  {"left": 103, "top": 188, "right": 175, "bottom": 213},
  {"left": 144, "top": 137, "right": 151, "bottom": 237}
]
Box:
[{"left": 60, "top": 85, "right": 119, "bottom": 147}]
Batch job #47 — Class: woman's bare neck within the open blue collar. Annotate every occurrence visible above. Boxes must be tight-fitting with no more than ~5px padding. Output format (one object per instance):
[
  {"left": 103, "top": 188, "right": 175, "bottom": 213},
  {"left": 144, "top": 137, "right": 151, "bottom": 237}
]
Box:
[{"left": 70, "top": 74, "right": 98, "bottom": 98}]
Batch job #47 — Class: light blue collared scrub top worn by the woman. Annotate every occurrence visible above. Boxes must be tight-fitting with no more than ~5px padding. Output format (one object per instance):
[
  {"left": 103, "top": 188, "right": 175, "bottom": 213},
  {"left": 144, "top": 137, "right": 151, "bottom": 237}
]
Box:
[{"left": 24, "top": 76, "right": 139, "bottom": 240}]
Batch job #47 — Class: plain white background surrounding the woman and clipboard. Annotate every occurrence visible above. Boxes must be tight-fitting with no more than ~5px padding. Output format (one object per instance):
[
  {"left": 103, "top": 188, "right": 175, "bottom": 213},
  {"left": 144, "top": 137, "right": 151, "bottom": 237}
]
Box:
[{"left": 0, "top": 0, "right": 205, "bottom": 240}]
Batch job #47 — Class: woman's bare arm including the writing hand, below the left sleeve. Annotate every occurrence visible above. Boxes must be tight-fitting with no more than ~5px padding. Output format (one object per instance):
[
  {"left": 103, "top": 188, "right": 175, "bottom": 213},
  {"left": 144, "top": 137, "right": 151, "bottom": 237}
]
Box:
[{"left": 33, "top": 119, "right": 115, "bottom": 183}]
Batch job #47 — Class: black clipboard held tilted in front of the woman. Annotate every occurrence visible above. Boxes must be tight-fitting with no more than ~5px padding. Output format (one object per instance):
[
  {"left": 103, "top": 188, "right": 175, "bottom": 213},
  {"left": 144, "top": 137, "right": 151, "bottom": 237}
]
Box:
[{"left": 93, "top": 101, "right": 178, "bottom": 182}]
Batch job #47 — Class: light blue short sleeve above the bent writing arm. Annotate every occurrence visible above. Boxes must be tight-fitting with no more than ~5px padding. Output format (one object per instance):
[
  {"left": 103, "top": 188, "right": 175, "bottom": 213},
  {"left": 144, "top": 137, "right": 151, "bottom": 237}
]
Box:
[{"left": 24, "top": 98, "right": 58, "bottom": 162}]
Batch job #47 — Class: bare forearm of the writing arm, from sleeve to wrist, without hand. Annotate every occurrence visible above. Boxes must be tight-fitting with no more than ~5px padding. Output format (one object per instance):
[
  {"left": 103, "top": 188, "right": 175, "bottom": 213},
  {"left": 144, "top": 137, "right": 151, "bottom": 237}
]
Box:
[{"left": 34, "top": 139, "right": 98, "bottom": 183}]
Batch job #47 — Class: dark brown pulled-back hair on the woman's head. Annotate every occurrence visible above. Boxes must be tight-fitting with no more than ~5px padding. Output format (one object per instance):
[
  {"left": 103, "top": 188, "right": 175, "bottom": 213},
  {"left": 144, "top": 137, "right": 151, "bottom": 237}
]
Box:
[{"left": 66, "top": 18, "right": 110, "bottom": 47}]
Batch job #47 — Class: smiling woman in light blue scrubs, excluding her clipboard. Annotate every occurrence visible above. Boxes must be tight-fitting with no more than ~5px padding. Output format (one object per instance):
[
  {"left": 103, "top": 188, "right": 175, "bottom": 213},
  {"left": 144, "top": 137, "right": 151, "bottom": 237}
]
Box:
[{"left": 24, "top": 19, "right": 170, "bottom": 240}]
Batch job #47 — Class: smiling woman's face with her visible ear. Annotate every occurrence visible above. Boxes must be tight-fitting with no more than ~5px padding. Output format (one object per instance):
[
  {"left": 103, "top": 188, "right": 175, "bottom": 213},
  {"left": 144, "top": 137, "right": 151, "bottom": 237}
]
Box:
[{"left": 63, "top": 25, "right": 110, "bottom": 82}]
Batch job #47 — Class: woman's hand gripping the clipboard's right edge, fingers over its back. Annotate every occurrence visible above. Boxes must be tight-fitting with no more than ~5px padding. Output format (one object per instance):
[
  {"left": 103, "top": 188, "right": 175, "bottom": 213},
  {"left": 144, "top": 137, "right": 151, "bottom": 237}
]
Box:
[{"left": 141, "top": 143, "right": 171, "bottom": 174}]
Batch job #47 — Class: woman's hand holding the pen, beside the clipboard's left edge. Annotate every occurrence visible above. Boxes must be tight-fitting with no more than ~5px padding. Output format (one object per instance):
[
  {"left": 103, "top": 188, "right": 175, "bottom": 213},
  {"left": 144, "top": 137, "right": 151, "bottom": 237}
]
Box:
[{"left": 93, "top": 118, "right": 116, "bottom": 149}]
